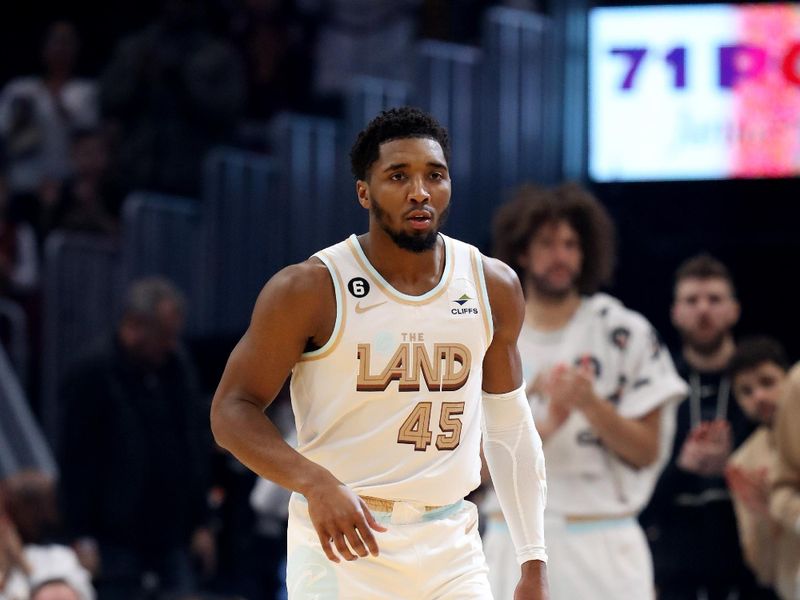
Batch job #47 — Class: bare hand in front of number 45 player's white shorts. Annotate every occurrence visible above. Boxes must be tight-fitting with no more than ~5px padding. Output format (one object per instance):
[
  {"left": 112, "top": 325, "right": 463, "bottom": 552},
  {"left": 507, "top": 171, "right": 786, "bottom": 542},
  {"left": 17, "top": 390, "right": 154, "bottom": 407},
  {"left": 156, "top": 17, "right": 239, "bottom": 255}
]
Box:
[{"left": 306, "top": 482, "right": 386, "bottom": 563}]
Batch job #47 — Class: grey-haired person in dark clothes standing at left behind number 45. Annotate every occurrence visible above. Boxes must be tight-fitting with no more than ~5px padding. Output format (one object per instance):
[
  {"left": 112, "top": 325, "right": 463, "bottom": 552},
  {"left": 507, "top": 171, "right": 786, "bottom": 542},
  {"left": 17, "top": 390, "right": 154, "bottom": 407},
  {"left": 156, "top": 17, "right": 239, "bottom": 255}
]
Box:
[{"left": 60, "top": 278, "right": 214, "bottom": 600}]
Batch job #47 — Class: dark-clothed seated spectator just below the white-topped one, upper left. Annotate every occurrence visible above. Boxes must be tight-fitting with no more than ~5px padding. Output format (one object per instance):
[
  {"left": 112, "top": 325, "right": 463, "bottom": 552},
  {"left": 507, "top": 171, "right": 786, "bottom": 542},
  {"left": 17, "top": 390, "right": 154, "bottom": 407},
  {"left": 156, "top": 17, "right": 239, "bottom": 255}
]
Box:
[{"left": 43, "top": 129, "right": 121, "bottom": 235}]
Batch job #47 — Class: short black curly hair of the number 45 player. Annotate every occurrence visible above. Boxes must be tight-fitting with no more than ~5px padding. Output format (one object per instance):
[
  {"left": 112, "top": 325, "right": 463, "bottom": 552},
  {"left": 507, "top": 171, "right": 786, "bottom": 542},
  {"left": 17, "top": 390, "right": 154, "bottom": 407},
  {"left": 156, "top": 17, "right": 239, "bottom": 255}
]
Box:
[{"left": 350, "top": 106, "right": 450, "bottom": 181}]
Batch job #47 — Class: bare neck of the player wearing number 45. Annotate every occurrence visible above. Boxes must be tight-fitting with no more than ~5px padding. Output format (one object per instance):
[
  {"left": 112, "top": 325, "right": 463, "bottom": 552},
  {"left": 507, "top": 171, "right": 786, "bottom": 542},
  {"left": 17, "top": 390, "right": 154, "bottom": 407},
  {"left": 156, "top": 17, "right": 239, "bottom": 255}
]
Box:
[{"left": 358, "top": 231, "right": 445, "bottom": 296}]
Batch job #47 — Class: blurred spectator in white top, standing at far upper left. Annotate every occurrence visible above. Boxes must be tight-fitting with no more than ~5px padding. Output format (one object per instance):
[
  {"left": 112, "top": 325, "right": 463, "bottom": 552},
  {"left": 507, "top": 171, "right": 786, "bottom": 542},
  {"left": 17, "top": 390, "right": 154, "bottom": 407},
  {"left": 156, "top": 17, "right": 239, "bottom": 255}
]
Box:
[{"left": 0, "top": 21, "right": 98, "bottom": 222}]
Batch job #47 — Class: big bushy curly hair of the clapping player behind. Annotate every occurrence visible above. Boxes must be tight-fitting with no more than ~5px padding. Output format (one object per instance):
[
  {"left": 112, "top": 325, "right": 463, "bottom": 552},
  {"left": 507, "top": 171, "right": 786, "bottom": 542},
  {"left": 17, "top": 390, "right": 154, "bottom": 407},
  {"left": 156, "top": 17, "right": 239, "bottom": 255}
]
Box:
[{"left": 492, "top": 183, "right": 615, "bottom": 294}]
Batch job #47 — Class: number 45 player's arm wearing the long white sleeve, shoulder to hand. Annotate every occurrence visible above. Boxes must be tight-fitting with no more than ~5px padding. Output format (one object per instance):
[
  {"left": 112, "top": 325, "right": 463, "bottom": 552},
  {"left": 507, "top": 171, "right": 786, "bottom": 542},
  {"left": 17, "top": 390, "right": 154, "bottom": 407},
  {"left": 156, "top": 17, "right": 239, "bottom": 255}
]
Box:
[{"left": 483, "top": 257, "right": 549, "bottom": 600}]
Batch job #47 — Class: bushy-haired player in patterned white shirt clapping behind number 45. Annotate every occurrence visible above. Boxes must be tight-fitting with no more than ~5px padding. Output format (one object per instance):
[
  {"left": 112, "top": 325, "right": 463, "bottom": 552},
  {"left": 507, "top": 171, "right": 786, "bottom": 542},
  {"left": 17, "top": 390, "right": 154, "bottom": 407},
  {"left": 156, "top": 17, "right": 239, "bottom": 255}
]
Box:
[{"left": 484, "top": 184, "right": 686, "bottom": 600}]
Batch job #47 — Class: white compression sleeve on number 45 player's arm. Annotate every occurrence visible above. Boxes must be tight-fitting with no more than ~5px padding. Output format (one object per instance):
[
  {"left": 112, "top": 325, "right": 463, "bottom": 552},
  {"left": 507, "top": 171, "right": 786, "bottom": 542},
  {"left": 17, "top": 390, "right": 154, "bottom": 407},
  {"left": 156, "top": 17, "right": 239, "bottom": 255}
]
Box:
[{"left": 483, "top": 383, "right": 547, "bottom": 564}]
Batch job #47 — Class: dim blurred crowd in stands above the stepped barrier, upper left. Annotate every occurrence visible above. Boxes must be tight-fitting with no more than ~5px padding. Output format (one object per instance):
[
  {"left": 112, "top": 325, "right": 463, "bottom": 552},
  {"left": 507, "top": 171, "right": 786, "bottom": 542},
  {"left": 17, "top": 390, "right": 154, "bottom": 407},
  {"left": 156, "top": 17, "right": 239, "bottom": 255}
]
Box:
[{"left": 0, "top": 0, "right": 536, "bottom": 398}]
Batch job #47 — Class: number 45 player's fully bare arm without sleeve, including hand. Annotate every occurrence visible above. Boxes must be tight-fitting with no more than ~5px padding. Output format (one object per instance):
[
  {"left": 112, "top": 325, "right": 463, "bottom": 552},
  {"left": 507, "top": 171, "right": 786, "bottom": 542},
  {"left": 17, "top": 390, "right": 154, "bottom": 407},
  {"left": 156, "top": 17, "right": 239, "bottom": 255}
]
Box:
[{"left": 211, "top": 259, "right": 384, "bottom": 562}]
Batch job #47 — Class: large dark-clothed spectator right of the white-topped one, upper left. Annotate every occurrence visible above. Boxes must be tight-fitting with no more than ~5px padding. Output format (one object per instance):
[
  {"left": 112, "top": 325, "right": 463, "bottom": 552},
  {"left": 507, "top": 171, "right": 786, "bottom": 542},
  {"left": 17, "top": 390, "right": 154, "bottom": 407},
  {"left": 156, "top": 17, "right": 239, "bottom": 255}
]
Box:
[{"left": 100, "top": 0, "right": 245, "bottom": 196}]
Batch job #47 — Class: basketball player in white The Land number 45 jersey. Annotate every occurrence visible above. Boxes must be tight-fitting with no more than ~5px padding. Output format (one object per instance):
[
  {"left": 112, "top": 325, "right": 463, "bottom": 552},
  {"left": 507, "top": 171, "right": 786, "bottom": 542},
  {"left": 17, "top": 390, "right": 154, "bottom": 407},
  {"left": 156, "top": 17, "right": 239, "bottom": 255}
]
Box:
[{"left": 211, "top": 108, "right": 547, "bottom": 600}]
